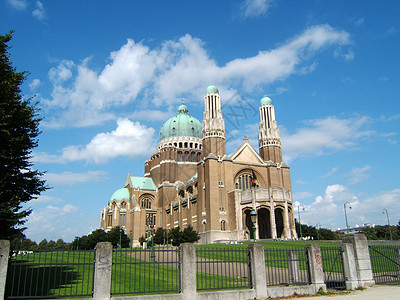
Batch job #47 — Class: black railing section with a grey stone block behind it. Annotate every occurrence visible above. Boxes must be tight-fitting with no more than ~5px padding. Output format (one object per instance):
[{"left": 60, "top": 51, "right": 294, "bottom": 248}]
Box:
[{"left": 264, "top": 248, "right": 310, "bottom": 286}]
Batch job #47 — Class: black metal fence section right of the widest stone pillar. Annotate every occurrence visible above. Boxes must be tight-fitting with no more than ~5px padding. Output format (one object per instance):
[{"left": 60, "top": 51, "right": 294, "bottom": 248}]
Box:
[{"left": 369, "top": 245, "right": 400, "bottom": 284}]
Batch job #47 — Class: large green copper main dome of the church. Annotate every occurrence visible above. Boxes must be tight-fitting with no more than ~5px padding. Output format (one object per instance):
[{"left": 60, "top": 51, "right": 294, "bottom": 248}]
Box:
[{"left": 159, "top": 104, "right": 202, "bottom": 142}]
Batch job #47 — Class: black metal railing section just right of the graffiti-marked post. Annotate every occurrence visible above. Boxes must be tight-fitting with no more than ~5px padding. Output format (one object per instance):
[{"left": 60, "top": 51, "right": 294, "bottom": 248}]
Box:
[{"left": 111, "top": 248, "right": 181, "bottom": 295}]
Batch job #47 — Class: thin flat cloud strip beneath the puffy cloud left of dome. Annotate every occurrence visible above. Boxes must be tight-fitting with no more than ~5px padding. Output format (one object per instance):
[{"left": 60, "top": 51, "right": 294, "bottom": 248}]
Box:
[{"left": 44, "top": 171, "right": 107, "bottom": 185}]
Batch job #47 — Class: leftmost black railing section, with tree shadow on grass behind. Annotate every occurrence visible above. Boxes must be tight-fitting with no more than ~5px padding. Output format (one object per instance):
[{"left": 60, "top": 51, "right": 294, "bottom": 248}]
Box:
[{"left": 6, "top": 250, "right": 95, "bottom": 299}]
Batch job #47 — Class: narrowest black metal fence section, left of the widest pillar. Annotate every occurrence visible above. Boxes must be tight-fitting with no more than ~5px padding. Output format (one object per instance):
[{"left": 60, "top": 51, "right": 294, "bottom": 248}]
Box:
[{"left": 321, "top": 247, "right": 346, "bottom": 290}]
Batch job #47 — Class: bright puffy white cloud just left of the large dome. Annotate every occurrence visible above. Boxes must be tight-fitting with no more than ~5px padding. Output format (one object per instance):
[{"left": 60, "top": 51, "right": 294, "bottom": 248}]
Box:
[{"left": 34, "top": 119, "right": 155, "bottom": 164}]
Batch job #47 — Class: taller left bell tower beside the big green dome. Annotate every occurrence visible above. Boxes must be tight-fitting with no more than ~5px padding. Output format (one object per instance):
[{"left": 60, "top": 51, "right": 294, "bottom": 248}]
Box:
[{"left": 202, "top": 84, "right": 226, "bottom": 157}]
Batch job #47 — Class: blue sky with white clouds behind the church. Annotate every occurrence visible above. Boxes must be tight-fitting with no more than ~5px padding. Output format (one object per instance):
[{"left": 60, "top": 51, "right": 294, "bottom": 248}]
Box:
[{"left": 0, "top": 0, "right": 400, "bottom": 242}]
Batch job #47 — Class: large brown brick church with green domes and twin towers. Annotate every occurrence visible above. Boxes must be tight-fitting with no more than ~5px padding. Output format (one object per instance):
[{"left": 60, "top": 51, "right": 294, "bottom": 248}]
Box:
[{"left": 101, "top": 84, "right": 297, "bottom": 245}]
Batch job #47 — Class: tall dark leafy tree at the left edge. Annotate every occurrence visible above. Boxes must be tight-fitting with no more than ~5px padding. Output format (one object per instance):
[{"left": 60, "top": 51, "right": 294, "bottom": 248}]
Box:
[{"left": 0, "top": 32, "right": 47, "bottom": 239}]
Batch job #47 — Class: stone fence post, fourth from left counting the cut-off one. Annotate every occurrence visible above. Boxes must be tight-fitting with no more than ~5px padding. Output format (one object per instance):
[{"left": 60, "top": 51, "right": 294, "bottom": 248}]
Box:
[{"left": 248, "top": 243, "right": 268, "bottom": 299}]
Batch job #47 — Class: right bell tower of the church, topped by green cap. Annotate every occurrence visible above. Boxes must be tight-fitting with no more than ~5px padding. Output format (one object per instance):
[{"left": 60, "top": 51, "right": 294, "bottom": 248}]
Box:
[{"left": 258, "top": 96, "right": 282, "bottom": 163}]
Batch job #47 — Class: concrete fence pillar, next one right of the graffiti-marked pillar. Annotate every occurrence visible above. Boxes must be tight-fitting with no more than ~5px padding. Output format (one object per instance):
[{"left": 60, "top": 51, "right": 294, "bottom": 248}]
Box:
[{"left": 179, "top": 243, "right": 196, "bottom": 300}]
